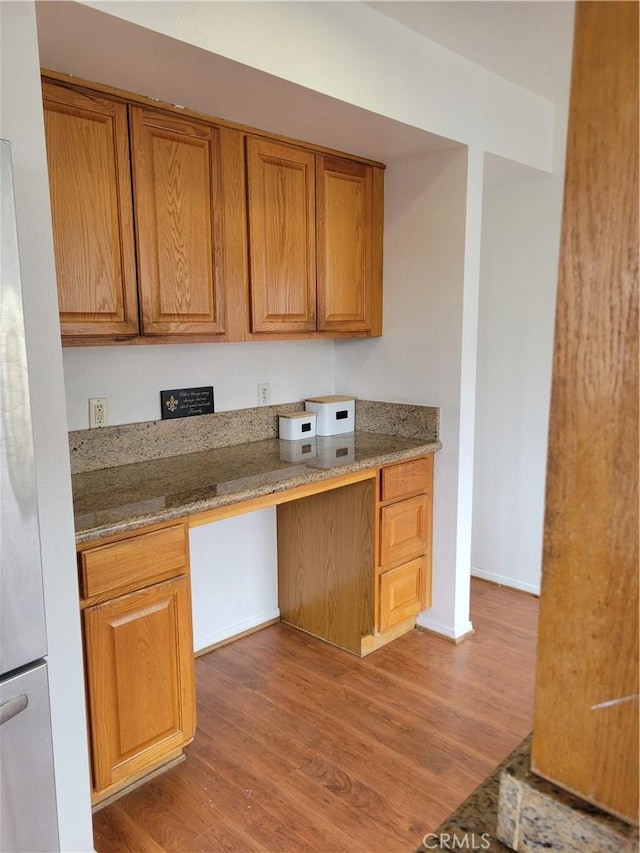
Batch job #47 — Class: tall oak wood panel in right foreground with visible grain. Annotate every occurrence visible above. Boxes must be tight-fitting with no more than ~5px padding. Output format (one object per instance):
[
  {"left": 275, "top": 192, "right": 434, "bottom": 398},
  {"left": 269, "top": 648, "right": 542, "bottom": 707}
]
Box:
[{"left": 533, "top": 2, "right": 638, "bottom": 823}]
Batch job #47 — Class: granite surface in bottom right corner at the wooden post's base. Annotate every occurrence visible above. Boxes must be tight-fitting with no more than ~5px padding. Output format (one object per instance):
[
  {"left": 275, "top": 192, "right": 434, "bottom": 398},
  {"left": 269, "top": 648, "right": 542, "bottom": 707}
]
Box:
[{"left": 417, "top": 735, "right": 638, "bottom": 853}]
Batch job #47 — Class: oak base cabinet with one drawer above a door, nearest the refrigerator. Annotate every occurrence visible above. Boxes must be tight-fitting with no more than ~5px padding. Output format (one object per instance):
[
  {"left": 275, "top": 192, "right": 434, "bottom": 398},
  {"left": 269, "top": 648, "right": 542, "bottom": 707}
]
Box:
[{"left": 79, "top": 524, "right": 195, "bottom": 802}]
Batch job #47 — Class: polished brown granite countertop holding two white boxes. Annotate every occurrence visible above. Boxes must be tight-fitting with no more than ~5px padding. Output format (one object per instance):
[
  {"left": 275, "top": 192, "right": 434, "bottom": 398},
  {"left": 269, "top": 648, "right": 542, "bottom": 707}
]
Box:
[{"left": 72, "top": 431, "right": 441, "bottom": 544}]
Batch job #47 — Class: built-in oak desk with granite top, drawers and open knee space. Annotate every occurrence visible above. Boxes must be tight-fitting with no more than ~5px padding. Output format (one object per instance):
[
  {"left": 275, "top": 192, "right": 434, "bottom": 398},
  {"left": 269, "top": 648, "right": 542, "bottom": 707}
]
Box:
[{"left": 73, "top": 432, "right": 440, "bottom": 803}]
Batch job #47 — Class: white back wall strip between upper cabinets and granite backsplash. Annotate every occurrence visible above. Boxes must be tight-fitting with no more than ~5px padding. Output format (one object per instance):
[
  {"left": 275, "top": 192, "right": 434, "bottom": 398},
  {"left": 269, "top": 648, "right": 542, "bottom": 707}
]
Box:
[{"left": 63, "top": 340, "right": 334, "bottom": 429}]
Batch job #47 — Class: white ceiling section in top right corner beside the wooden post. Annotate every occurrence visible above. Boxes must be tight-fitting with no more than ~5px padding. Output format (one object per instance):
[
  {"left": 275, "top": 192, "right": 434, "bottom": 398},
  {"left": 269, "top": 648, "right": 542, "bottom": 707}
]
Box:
[{"left": 366, "top": 0, "right": 575, "bottom": 102}]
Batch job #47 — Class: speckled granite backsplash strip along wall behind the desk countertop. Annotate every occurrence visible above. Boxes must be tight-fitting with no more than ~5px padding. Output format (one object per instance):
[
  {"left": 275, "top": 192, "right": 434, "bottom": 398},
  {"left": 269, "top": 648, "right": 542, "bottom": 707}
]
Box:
[{"left": 69, "top": 400, "right": 439, "bottom": 474}]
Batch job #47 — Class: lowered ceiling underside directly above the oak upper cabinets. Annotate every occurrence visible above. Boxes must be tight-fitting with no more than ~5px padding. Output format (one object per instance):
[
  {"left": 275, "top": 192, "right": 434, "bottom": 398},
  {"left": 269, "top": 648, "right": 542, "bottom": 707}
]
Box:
[{"left": 36, "top": 0, "right": 459, "bottom": 163}]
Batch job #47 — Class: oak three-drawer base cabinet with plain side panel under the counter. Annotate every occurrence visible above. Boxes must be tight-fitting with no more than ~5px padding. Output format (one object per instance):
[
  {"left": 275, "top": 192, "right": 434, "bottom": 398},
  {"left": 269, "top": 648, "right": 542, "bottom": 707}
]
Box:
[{"left": 278, "top": 454, "right": 433, "bottom": 656}]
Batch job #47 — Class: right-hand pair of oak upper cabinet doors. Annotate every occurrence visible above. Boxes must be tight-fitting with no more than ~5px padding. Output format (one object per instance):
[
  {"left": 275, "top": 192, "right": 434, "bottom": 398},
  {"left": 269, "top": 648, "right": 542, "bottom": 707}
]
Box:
[{"left": 247, "top": 137, "right": 382, "bottom": 335}]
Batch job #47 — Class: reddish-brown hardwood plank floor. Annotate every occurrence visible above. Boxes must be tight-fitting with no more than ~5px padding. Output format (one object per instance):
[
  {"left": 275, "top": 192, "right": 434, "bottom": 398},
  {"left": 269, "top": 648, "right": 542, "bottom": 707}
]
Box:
[{"left": 94, "top": 580, "right": 538, "bottom": 853}]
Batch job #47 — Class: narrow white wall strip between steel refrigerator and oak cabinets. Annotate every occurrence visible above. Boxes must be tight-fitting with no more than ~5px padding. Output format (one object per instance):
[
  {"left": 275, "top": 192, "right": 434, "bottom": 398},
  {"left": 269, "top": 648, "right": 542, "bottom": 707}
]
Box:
[{"left": 0, "top": 2, "right": 93, "bottom": 853}]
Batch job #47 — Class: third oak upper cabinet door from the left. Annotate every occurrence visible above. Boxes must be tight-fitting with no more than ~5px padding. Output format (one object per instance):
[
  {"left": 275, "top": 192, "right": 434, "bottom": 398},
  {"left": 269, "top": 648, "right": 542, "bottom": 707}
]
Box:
[{"left": 247, "top": 137, "right": 316, "bottom": 332}]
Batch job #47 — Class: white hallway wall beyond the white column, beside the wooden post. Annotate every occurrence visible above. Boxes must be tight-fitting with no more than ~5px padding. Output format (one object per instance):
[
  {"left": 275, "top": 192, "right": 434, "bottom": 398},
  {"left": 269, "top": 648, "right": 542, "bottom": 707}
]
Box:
[{"left": 472, "top": 146, "right": 564, "bottom": 594}]
